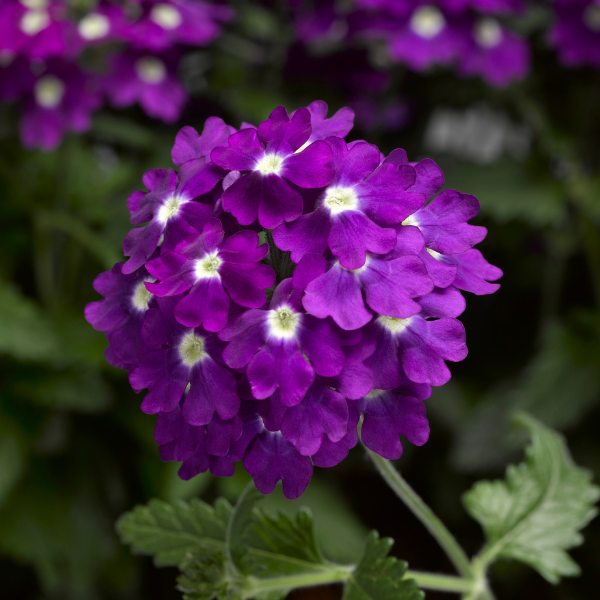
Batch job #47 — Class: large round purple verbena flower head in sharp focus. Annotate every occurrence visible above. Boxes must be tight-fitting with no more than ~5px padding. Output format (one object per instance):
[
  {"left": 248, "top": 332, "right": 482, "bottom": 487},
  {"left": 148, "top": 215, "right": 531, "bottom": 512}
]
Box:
[{"left": 86, "top": 101, "right": 502, "bottom": 498}]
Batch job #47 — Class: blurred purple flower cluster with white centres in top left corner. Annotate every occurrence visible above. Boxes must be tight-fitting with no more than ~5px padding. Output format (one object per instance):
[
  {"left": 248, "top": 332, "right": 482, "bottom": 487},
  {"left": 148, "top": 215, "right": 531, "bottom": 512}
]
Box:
[{"left": 0, "top": 0, "right": 233, "bottom": 150}]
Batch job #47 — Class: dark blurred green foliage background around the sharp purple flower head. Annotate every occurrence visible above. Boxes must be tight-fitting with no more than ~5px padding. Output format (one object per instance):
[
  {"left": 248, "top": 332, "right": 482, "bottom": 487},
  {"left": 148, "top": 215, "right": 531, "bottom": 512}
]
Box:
[{"left": 0, "top": 1, "right": 600, "bottom": 600}]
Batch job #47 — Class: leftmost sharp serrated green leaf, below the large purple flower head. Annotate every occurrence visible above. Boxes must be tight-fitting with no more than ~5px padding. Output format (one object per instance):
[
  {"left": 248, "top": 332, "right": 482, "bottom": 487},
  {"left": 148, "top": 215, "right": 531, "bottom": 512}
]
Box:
[{"left": 117, "top": 498, "right": 233, "bottom": 566}]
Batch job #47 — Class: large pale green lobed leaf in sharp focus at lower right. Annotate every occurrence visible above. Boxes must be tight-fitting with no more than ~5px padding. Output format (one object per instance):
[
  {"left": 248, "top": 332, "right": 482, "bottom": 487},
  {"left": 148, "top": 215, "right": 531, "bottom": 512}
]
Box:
[{"left": 463, "top": 413, "right": 600, "bottom": 583}]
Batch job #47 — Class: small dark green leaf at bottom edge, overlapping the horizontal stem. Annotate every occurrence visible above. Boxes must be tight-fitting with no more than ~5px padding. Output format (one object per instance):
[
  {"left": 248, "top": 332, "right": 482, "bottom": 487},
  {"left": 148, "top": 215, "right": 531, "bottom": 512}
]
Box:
[{"left": 344, "top": 531, "right": 425, "bottom": 600}]
